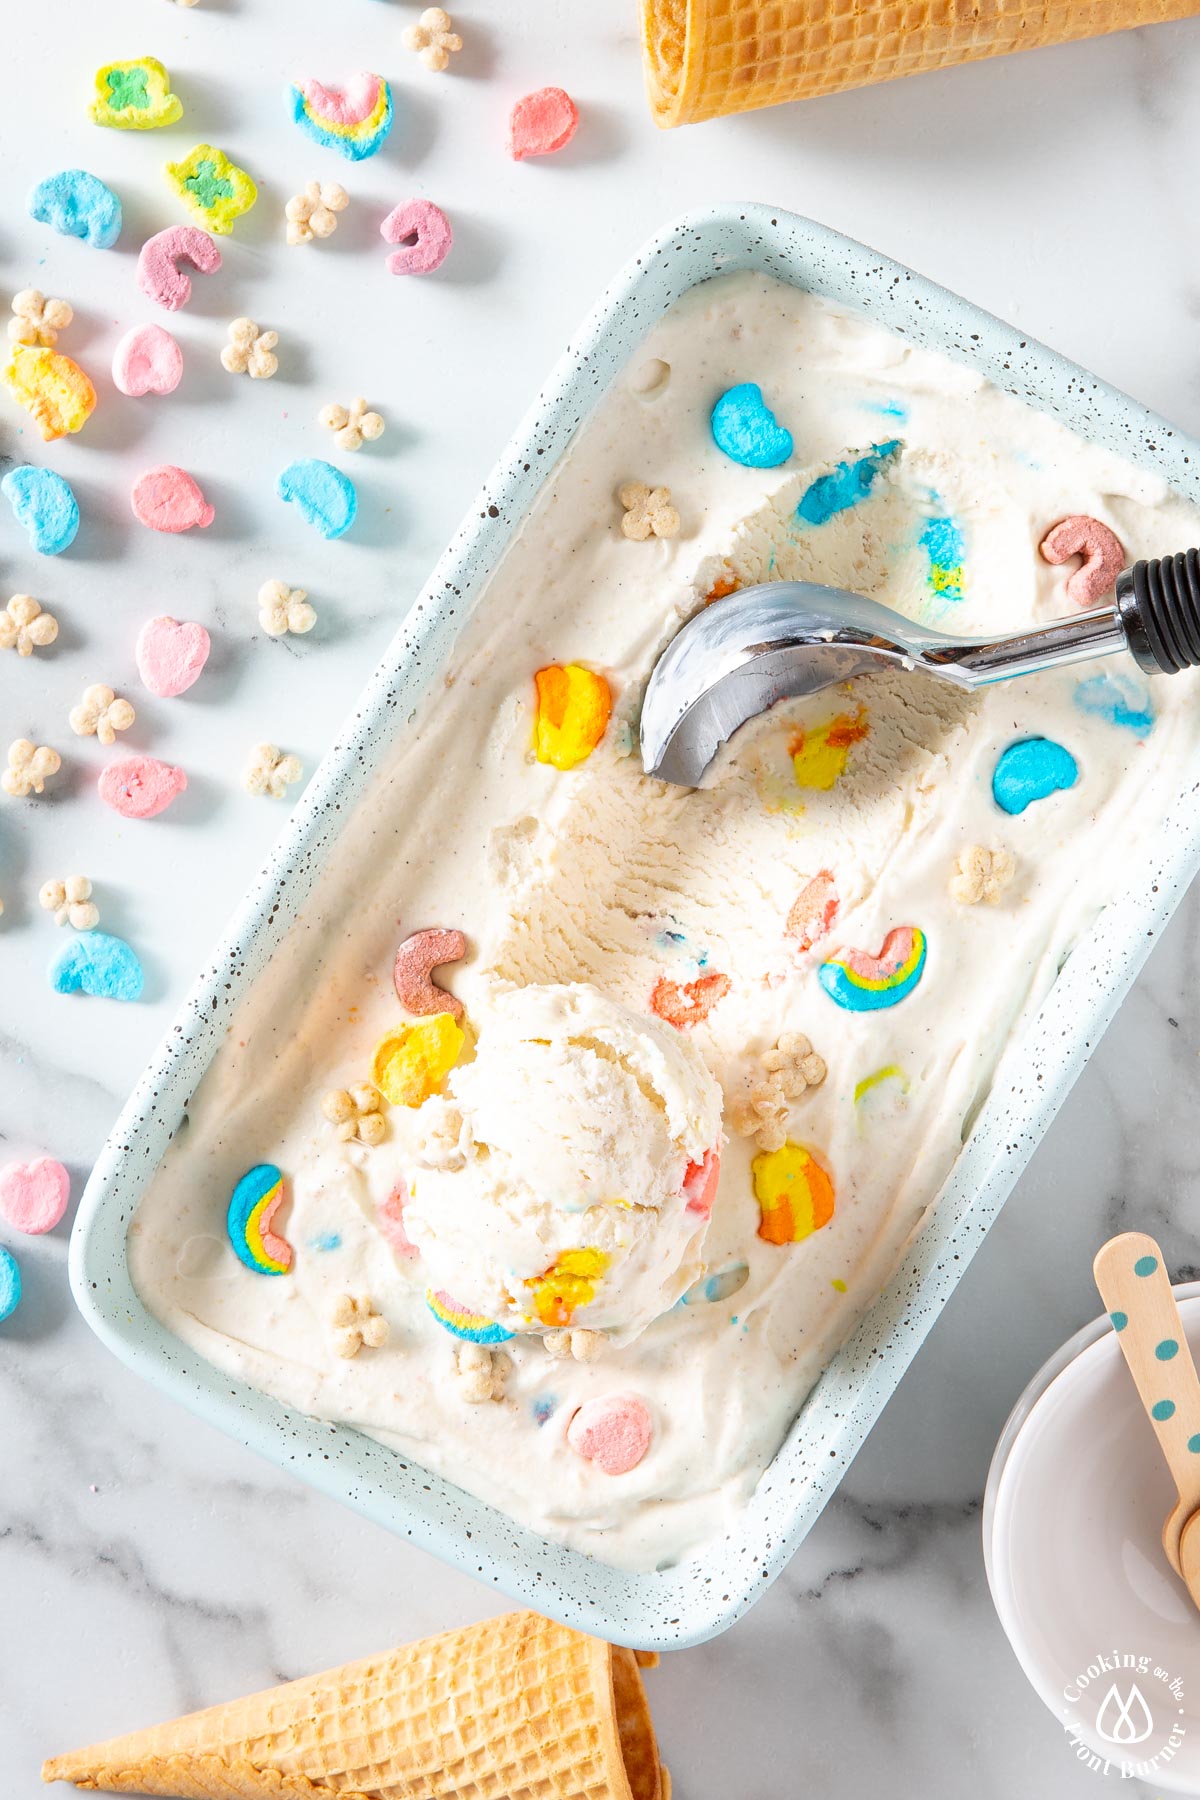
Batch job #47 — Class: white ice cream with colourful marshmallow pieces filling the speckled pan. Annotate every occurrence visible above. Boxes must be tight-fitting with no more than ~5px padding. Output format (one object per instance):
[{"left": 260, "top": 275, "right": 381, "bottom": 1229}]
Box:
[{"left": 130, "top": 274, "right": 1200, "bottom": 1568}]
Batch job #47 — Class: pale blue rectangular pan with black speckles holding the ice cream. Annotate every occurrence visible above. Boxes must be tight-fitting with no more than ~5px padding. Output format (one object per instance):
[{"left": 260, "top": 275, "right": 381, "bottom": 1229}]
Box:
[{"left": 70, "top": 205, "right": 1200, "bottom": 1649}]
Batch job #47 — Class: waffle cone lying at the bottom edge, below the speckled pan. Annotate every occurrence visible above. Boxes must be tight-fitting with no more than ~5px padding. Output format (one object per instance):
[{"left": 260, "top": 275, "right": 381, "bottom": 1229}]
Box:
[{"left": 41, "top": 1613, "right": 669, "bottom": 1800}]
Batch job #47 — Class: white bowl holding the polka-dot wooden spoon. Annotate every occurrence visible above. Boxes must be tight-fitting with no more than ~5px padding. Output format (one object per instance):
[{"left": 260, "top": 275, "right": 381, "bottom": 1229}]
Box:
[{"left": 984, "top": 1282, "right": 1200, "bottom": 1795}]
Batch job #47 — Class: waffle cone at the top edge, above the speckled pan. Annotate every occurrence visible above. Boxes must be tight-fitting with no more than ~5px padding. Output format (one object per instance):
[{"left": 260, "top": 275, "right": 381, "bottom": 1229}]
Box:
[{"left": 640, "top": 0, "right": 1200, "bottom": 126}]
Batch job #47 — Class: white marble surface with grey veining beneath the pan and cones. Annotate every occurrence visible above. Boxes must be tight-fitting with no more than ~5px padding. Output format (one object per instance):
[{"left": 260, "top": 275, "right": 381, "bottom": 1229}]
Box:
[{"left": 0, "top": 0, "right": 1200, "bottom": 1800}]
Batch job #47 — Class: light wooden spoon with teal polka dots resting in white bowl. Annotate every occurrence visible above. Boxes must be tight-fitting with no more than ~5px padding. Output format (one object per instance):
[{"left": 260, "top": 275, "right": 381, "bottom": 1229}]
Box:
[{"left": 1092, "top": 1231, "right": 1200, "bottom": 1606}]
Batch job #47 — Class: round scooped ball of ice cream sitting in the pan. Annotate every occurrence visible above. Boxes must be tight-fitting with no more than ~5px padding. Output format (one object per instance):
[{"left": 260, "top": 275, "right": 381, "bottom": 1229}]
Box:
[{"left": 403, "top": 985, "right": 721, "bottom": 1341}]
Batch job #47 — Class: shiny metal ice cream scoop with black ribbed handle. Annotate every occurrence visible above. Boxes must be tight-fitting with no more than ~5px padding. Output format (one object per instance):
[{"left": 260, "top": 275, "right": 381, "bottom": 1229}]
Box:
[{"left": 640, "top": 549, "right": 1200, "bottom": 787}]
